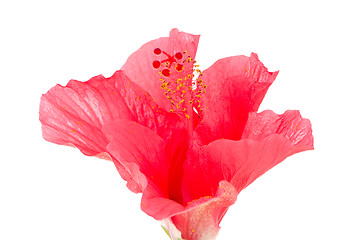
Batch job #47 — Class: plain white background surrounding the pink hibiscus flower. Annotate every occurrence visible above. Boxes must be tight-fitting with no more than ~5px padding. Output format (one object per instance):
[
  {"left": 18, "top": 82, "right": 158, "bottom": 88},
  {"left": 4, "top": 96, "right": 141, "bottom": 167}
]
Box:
[{"left": 0, "top": 0, "right": 362, "bottom": 240}]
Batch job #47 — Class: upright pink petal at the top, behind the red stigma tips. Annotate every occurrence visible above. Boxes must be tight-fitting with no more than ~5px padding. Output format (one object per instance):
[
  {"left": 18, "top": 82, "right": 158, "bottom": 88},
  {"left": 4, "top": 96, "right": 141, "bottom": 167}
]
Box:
[{"left": 122, "top": 29, "right": 199, "bottom": 110}]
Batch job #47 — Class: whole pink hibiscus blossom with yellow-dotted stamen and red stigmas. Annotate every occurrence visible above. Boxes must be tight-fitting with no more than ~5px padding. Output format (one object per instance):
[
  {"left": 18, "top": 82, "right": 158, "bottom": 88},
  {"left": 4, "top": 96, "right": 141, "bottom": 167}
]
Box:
[{"left": 40, "top": 29, "right": 313, "bottom": 240}]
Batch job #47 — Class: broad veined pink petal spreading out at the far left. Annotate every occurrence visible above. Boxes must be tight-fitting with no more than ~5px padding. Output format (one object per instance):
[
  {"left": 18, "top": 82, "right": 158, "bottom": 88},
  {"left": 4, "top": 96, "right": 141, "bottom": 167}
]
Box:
[{"left": 39, "top": 71, "right": 132, "bottom": 155}]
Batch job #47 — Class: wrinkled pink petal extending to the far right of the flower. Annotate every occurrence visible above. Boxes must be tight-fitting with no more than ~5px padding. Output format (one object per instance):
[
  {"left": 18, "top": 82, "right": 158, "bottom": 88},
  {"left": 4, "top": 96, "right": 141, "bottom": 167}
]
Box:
[{"left": 231, "top": 110, "right": 314, "bottom": 191}]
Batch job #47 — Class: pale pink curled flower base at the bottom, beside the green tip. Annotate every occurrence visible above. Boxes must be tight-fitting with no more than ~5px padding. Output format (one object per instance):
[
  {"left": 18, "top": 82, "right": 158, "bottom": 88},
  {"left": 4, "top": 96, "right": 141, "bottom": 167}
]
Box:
[{"left": 166, "top": 181, "right": 238, "bottom": 240}]
